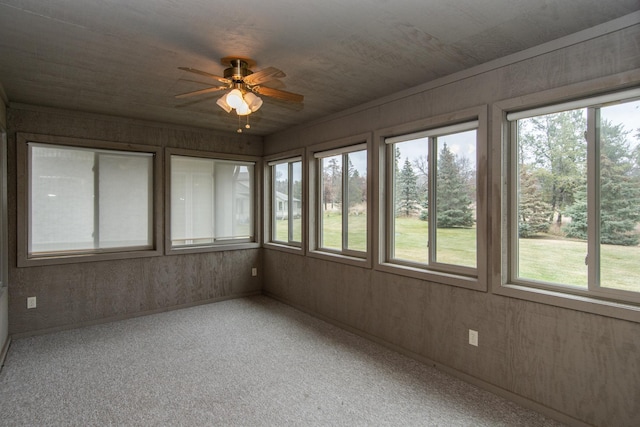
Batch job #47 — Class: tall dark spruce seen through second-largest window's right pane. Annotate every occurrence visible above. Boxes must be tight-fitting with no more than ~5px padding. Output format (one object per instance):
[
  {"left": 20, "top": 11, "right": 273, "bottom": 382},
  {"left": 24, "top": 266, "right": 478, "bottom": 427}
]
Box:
[{"left": 436, "top": 143, "right": 475, "bottom": 228}]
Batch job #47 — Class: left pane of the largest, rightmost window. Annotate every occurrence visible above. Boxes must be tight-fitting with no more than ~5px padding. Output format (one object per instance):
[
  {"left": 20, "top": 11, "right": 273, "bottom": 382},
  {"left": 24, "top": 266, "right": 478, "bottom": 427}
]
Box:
[{"left": 516, "top": 109, "right": 587, "bottom": 288}]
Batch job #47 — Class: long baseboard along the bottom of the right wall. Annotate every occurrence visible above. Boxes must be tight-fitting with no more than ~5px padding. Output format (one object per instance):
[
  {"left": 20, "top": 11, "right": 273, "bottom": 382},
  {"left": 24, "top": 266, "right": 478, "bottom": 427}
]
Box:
[{"left": 262, "top": 290, "right": 589, "bottom": 427}]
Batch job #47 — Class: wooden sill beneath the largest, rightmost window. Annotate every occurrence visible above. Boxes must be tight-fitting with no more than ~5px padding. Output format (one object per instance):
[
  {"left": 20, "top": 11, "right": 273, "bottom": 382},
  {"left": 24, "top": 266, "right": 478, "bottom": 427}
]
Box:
[{"left": 493, "top": 284, "right": 640, "bottom": 323}]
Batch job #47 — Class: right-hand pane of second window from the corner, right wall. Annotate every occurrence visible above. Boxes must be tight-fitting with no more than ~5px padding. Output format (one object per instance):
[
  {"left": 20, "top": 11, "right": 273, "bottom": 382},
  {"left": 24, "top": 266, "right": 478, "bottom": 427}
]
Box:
[{"left": 346, "top": 150, "right": 367, "bottom": 252}]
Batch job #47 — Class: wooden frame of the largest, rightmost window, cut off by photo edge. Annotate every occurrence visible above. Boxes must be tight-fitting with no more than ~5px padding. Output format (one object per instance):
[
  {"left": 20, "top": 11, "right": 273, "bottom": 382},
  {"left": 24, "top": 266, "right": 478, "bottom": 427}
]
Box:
[{"left": 490, "top": 70, "right": 640, "bottom": 323}]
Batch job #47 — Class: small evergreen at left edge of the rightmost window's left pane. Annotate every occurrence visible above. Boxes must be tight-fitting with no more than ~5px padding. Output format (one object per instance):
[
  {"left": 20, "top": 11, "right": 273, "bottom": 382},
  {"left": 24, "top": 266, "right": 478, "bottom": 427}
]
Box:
[{"left": 518, "top": 165, "right": 553, "bottom": 238}]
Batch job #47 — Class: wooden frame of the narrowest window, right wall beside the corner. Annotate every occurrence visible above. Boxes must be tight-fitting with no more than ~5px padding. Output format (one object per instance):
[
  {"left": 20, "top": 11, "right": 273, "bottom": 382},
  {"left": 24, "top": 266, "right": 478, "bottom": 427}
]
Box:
[{"left": 263, "top": 149, "right": 307, "bottom": 255}]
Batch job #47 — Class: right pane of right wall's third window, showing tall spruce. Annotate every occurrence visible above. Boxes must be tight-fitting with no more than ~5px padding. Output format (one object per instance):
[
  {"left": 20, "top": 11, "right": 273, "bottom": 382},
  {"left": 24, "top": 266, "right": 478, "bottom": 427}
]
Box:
[{"left": 435, "top": 130, "right": 477, "bottom": 268}]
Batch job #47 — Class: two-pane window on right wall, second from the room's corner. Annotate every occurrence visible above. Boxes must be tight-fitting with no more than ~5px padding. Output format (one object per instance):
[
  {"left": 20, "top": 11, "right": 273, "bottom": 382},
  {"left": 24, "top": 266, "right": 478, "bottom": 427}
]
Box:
[{"left": 314, "top": 143, "right": 368, "bottom": 258}]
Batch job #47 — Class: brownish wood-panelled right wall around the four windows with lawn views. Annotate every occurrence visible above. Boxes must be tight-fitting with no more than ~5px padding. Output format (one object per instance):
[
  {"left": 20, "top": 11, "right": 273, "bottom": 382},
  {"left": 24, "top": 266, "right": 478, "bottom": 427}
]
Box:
[{"left": 264, "top": 19, "right": 640, "bottom": 426}]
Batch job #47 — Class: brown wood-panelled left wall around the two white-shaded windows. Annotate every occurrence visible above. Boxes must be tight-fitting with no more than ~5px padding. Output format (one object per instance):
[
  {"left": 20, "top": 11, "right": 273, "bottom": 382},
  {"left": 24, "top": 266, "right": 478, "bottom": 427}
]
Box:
[{"left": 8, "top": 105, "right": 262, "bottom": 338}]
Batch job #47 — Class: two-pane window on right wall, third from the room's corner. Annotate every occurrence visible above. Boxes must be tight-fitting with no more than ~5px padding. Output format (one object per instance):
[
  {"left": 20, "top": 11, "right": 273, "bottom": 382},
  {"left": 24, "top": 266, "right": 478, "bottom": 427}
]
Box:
[{"left": 384, "top": 120, "right": 478, "bottom": 276}]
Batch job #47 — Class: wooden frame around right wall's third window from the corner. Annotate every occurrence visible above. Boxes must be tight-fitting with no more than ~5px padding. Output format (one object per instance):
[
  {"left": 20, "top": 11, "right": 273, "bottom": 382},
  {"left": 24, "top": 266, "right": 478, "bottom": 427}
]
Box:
[{"left": 374, "top": 105, "right": 489, "bottom": 292}]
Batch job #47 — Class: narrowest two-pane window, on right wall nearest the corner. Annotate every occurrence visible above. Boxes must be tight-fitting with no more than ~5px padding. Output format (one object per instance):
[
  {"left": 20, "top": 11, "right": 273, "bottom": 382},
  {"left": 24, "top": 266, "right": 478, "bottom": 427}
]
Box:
[{"left": 269, "top": 157, "right": 302, "bottom": 247}]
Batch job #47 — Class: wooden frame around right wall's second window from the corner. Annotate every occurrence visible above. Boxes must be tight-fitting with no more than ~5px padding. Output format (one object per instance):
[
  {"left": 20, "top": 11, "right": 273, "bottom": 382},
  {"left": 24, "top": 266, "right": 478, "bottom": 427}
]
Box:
[{"left": 306, "top": 133, "right": 374, "bottom": 268}]
